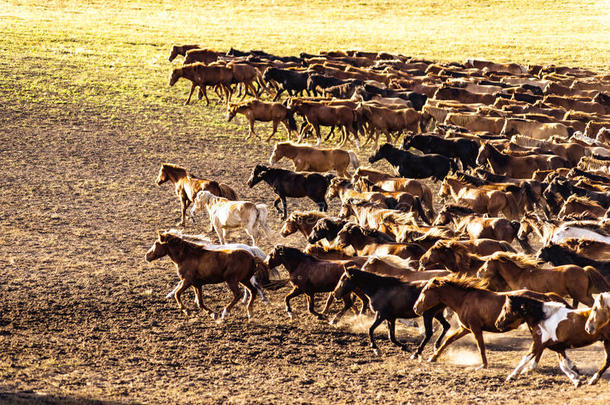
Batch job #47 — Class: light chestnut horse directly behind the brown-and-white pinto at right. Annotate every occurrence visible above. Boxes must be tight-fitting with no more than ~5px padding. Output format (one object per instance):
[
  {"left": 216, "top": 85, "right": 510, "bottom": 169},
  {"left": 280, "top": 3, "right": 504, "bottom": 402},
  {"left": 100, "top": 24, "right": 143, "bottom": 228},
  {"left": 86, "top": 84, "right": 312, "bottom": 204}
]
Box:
[{"left": 477, "top": 252, "right": 610, "bottom": 308}]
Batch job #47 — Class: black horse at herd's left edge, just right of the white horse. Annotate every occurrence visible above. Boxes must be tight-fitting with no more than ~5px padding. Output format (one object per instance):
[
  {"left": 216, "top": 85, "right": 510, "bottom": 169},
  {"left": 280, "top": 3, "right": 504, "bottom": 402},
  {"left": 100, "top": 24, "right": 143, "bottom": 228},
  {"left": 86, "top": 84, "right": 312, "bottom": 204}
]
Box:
[{"left": 247, "top": 165, "right": 335, "bottom": 219}]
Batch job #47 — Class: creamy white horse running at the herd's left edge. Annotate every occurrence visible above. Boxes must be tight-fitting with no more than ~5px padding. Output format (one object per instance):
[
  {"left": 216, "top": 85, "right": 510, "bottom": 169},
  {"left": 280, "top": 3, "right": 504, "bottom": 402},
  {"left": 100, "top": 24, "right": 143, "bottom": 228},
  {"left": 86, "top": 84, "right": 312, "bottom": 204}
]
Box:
[{"left": 190, "top": 191, "right": 271, "bottom": 246}]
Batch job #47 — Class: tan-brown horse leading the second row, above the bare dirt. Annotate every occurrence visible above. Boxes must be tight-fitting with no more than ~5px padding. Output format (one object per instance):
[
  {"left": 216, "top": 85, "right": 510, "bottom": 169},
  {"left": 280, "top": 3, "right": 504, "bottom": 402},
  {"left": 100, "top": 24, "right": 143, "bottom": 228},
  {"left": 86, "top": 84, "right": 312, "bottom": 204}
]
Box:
[{"left": 227, "top": 100, "right": 297, "bottom": 142}]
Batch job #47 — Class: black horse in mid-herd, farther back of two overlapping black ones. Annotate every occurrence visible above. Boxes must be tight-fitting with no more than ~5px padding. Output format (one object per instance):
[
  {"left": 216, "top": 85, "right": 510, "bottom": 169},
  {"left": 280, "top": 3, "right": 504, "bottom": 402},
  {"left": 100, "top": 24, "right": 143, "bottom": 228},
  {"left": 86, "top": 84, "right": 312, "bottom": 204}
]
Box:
[{"left": 402, "top": 135, "right": 479, "bottom": 170}]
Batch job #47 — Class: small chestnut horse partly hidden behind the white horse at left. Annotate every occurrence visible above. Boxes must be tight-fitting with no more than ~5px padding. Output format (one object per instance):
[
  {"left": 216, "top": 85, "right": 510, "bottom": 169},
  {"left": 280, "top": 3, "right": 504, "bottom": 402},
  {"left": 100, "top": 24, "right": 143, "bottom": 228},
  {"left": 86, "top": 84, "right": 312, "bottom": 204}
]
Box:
[{"left": 156, "top": 163, "right": 237, "bottom": 226}]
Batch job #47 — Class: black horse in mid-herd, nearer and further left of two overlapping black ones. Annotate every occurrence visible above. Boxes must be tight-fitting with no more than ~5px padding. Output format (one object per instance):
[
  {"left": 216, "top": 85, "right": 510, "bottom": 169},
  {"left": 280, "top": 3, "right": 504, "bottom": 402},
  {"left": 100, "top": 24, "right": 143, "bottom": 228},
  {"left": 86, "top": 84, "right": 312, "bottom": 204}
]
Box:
[{"left": 369, "top": 143, "right": 458, "bottom": 180}]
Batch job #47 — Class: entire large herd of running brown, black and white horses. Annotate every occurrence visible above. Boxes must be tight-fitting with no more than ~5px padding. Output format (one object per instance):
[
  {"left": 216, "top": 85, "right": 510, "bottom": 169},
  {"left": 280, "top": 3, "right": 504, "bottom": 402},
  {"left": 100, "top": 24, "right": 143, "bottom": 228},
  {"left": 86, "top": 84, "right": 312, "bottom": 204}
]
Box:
[{"left": 153, "top": 45, "right": 610, "bottom": 386}]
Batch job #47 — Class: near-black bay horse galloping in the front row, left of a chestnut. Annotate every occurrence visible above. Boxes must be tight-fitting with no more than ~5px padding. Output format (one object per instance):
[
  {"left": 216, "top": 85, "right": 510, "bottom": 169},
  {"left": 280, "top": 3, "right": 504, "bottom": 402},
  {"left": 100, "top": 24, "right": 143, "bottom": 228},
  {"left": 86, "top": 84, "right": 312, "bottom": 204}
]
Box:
[{"left": 333, "top": 267, "right": 450, "bottom": 358}]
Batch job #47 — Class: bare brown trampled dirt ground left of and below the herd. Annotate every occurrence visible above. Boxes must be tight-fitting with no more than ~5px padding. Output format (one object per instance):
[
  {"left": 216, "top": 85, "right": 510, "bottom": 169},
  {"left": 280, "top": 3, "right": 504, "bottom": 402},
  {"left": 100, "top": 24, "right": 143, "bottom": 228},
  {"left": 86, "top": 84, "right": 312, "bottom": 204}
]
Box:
[{"left": 0, "top": 96, "right": 610, "bottom": 404}]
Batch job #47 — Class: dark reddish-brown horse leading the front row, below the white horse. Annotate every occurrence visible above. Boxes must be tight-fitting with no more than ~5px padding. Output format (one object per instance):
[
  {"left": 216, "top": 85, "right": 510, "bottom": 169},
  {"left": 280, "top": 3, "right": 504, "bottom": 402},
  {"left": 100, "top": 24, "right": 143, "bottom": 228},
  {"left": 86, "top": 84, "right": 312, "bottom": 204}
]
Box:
[{"left": 146, "top": 232, "right": 268, "bottom": 319}]
